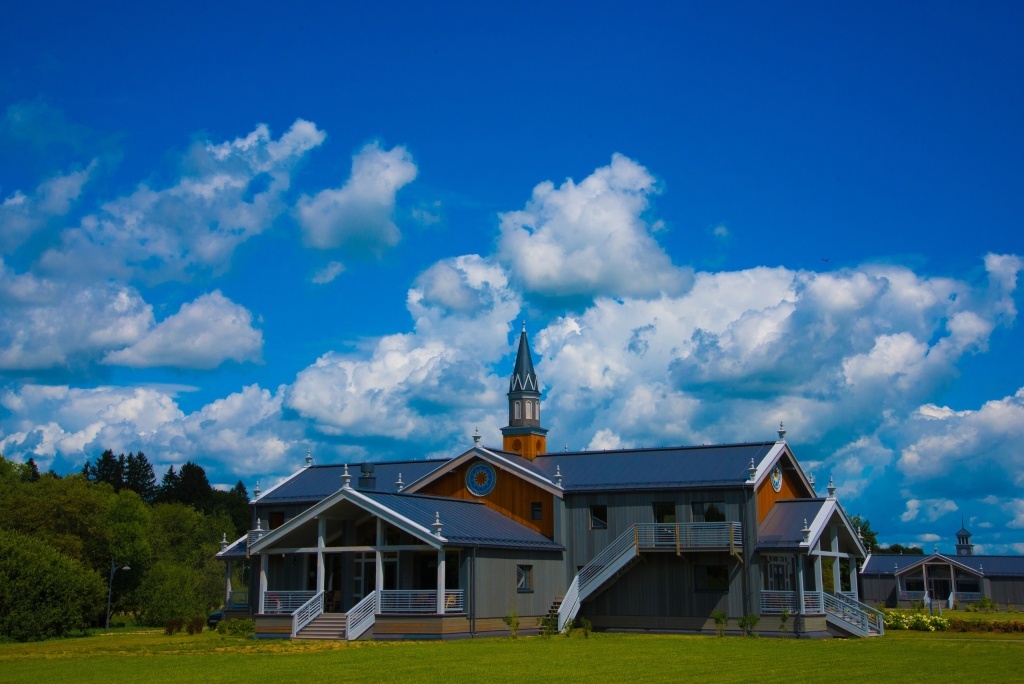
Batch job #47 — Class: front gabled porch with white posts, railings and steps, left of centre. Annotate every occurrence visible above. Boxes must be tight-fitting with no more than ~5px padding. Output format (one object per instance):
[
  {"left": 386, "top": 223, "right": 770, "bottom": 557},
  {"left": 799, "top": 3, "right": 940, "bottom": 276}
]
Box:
[{"left": 249, "top": 483, "right": 466, "bottom": 640}]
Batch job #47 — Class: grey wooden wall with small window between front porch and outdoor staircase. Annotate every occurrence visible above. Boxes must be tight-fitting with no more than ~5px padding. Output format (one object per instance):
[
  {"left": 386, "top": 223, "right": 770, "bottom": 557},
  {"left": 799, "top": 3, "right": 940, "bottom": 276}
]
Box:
[{"left": 465, "top": 549, "right": 567, "bottom": 618}]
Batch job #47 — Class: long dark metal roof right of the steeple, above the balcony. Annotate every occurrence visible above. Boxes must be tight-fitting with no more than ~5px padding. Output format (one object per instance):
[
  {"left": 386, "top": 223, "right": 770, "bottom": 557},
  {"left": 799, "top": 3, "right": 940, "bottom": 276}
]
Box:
[{"left": 532, "top": 441, "right": 776, "bottom": 491}]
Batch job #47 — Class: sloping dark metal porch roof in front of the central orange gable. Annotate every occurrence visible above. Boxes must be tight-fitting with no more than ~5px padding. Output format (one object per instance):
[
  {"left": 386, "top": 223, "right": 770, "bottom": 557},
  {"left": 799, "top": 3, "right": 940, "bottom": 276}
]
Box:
[{"left": 361, "top": 490, "right": 563, "bottom": 551}]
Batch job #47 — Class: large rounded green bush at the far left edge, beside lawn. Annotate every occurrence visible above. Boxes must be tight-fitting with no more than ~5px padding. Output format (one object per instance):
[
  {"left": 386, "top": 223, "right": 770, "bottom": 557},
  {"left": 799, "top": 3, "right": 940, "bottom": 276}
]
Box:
[{"left": 0, "top": 530, "right": 106, "bottom": 641}]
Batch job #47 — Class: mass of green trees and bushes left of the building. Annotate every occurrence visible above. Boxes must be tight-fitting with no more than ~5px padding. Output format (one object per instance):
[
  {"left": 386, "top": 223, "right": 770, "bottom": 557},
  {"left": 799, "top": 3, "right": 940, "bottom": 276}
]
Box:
[{"left": 0, "top": 450, "right": 249, "bottom": 641}]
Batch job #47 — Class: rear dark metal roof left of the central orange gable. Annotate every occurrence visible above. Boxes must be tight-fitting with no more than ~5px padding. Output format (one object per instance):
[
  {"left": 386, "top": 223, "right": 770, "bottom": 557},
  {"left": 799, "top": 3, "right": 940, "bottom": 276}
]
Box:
[{"left": 257, "top": 459, "right": 450, "bottom": 504}]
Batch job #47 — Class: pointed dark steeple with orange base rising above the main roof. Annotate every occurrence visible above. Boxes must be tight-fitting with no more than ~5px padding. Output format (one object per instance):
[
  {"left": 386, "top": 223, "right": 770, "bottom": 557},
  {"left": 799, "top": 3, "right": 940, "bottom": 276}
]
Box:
[{"left": 502, "top": 323, "right": 548, "bottom": 461}]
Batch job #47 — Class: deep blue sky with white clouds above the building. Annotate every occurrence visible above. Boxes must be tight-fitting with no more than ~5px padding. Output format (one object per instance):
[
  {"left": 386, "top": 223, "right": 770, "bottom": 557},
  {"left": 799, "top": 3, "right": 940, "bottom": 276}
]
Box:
[{"left": 0, "top": 2, "right": 1024, "bottom": 553}]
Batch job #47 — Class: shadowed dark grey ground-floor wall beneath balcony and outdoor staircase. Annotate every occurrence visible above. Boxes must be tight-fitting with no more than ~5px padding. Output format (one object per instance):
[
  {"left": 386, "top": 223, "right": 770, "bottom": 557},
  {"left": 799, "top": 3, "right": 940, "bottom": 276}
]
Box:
[{"left": 580, "top": 553, "right": 751, "bottom": 618}]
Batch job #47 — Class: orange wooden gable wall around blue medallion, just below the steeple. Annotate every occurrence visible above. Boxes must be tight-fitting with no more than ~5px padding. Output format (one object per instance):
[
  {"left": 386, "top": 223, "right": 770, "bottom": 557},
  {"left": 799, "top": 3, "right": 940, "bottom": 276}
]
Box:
[{"left": 417, "top": 459, "right": 555, "bottom": 539}]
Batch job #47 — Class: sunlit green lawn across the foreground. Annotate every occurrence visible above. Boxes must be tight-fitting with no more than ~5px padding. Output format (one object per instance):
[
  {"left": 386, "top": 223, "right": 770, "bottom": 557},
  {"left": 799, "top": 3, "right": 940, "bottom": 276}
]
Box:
[{"left": 0, "top": 632, "right": 1024, "bottom": 684}]
